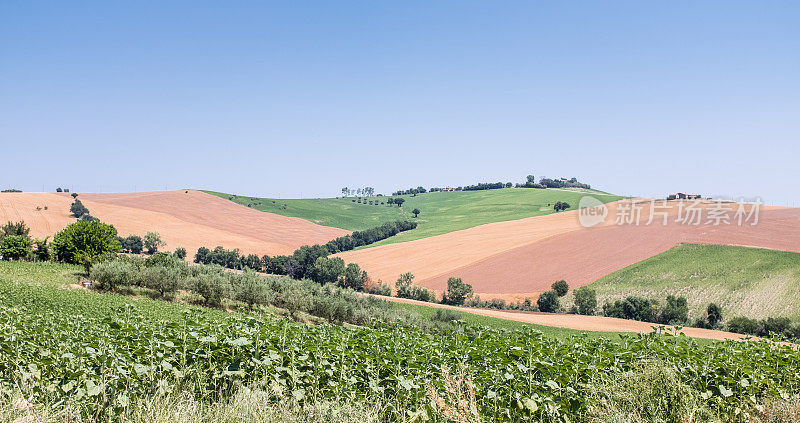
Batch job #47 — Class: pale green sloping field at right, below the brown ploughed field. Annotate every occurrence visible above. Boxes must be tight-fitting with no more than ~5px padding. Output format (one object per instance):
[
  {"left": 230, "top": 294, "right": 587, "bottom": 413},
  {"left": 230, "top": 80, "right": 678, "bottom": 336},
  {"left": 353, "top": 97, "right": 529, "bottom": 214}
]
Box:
[{"left": 590, "top": 244, "right": 800, "bottom": 321}]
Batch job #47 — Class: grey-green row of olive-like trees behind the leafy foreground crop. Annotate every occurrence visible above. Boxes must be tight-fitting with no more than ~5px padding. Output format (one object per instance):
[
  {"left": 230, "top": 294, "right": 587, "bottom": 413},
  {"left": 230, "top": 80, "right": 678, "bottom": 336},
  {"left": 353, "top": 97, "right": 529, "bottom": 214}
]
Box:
[{"left": 90, "top": 254, "right": 462, "bottom": 331}]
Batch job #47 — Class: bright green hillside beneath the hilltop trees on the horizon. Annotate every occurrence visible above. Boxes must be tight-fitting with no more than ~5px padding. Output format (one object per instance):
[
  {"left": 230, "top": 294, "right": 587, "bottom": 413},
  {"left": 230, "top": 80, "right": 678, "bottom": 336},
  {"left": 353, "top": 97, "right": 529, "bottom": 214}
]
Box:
[{"left": 204, "top": 188, "right": 623, "bottom": 246}]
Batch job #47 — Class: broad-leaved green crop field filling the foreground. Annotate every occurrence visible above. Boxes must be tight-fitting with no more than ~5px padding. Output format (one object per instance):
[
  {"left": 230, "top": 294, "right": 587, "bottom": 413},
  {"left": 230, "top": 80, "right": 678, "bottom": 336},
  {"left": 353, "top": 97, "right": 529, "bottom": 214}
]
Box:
[{"left": 0, "top": 262, "right": 800, "bottom": 422}]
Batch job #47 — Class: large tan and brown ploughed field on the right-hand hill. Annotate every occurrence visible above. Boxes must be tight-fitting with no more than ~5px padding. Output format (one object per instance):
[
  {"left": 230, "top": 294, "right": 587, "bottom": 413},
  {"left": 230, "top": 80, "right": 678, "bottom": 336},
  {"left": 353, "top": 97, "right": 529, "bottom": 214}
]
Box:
[{"left": 340, "top": 203, "right": 800, "bottom": 301}]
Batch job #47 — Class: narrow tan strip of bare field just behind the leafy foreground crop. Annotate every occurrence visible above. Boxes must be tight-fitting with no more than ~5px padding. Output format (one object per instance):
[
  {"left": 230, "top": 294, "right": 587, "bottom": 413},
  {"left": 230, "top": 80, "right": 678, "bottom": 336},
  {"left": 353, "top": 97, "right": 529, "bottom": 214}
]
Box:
[{"left": 378, "top": 297, "right": 747, "bottom": 341}]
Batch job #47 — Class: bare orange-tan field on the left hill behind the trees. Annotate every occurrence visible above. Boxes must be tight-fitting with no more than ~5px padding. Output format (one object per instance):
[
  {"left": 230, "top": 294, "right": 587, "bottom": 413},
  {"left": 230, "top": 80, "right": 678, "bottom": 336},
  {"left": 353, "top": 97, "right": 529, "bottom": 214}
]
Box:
[{"left": 0, "top": 191, "right": 349, "bottom": 255}]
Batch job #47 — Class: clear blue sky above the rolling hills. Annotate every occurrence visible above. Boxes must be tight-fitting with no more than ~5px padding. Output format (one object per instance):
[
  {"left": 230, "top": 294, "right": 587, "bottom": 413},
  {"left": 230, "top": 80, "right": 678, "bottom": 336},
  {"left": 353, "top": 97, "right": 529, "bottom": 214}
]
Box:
[{"left": 0, "top": 0, "right": 800, "bottom": 205}]
